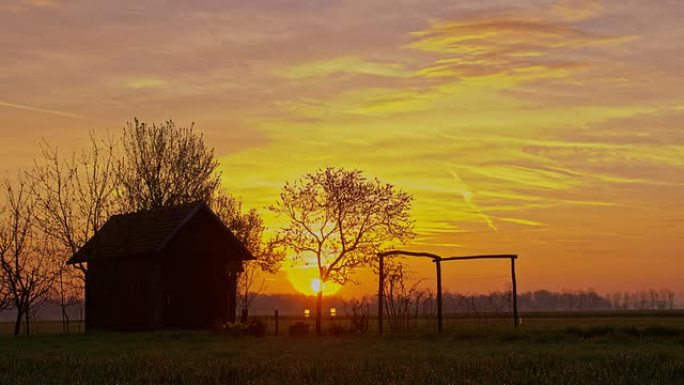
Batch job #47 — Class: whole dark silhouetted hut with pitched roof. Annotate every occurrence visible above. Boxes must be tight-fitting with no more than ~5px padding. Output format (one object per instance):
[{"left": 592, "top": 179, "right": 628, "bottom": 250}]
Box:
[{"left": 67, "top": 202, "right": 254, "bottom": 330}]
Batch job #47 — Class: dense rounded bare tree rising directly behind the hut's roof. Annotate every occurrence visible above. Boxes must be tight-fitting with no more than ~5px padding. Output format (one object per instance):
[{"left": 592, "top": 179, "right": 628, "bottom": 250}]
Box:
[{"left": 116, "top": 119, "right": 221, "bottom": 211}]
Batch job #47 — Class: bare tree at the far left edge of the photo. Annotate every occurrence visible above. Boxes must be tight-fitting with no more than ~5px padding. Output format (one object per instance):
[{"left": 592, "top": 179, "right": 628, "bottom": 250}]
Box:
[{"left": 0, "top": 177, "right": 58, "bottom": 335}]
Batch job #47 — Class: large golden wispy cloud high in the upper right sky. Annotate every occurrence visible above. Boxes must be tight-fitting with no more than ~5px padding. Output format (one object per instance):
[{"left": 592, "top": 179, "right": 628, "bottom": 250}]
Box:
[{"left": 408, "top": 13, "right": 632, "bottom": 79}]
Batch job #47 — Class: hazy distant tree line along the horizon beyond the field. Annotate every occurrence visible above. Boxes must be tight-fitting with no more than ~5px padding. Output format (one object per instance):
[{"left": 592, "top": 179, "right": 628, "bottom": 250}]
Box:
[{"left": 0, "top": 287, "right": 684, "bottom": 329}]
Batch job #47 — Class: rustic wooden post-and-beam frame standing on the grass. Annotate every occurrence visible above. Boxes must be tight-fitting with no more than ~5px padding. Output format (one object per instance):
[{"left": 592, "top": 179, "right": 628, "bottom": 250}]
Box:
[{"left": 378, "top": 250, "right": 520, "bottom": 334}]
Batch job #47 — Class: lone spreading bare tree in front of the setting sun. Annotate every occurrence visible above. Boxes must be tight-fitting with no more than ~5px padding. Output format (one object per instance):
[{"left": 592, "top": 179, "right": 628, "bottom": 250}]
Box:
[{"left": 271, "top": 167, "right": 413, "bottom": 334}]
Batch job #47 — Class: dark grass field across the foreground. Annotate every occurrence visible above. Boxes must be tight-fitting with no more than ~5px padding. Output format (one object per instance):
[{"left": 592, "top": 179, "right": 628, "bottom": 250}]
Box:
[{"left": 0, "top": 314, "right": 684, "bottom": 385}]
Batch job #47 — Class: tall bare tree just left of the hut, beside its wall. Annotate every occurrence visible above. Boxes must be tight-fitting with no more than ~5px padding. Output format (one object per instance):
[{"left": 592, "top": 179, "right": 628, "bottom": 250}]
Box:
[{"left": 31, "top": 133, "right": 117, "bottom": 332}]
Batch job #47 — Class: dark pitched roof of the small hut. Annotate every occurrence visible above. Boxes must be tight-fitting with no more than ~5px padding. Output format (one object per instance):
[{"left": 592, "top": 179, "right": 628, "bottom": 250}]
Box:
[{"left": 67, "top": 202, "right": 254, "bottom": 264}]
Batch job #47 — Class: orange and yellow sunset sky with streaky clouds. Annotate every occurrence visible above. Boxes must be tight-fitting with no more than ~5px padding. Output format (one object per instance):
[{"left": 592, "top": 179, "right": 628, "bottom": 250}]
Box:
[{"left": 0, "top": 0, "right": 684, "bottom": 295}]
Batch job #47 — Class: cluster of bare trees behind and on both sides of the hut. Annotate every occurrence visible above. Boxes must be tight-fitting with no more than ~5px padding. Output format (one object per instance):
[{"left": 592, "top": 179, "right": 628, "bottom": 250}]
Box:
[{"left": 0, "top": 119, "right": 284, "bottom": 334}]
